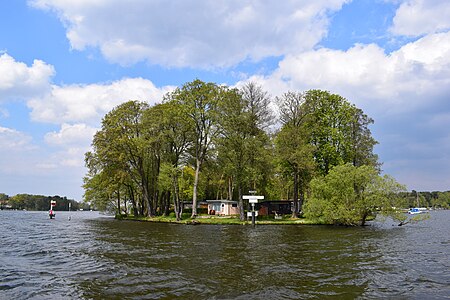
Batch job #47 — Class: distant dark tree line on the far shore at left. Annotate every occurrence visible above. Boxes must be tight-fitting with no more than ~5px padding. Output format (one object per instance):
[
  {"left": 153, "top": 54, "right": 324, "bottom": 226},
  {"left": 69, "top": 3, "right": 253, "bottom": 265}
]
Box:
[{"left": 0, "top": 193, "right": 89, "bottom": 211}]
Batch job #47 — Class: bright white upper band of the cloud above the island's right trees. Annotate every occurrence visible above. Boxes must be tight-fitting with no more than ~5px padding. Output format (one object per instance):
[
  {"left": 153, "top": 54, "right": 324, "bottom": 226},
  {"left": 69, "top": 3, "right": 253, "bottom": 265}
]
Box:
[{"left": 246, "top": 32, "right": 450, "bottom": 112}]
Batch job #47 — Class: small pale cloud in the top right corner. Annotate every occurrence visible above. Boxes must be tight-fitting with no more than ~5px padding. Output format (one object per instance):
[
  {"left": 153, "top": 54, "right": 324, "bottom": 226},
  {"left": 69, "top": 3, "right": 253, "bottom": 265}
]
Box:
[{"left": 391, "top": 0, "right": 450, "bottom": 36}]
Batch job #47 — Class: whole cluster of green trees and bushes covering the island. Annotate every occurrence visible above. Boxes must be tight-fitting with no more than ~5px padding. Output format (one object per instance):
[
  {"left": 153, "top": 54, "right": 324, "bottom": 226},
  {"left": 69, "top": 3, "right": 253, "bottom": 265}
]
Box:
[{"left": 84, "top": 80, "right": 448, "bottom": 224}]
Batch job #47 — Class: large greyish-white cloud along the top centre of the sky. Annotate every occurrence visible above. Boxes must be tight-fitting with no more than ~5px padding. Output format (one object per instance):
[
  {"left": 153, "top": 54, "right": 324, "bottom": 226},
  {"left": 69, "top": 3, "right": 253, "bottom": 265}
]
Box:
[{"left": 30, "top": 0, "right": 348, "bottom": 68}]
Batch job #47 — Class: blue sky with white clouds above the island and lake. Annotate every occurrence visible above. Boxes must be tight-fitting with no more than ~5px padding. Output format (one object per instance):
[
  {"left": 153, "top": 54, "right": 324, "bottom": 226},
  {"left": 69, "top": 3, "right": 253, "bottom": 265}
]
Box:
[{"left": 0, "top": 0, "right": 450, "bottom": 201}]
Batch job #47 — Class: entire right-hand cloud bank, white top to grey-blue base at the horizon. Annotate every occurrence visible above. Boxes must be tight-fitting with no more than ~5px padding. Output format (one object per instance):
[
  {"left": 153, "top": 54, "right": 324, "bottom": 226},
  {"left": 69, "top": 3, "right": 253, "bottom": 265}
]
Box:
[{"left": 239, "top": 32, "right": 450, "bottom": 190}]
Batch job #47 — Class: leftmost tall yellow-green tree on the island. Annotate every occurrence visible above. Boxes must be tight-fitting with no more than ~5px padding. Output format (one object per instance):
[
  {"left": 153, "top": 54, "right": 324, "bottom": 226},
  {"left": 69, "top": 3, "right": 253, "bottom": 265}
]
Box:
[{"left": 85, "top": 101, "right": 157, "bottom": 216}]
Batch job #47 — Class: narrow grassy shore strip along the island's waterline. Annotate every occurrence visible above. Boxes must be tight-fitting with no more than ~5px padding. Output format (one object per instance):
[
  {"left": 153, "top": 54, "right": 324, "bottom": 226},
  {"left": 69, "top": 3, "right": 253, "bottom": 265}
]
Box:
[{"left": 116, "top": 215, "right": 324, "bottom": 225}]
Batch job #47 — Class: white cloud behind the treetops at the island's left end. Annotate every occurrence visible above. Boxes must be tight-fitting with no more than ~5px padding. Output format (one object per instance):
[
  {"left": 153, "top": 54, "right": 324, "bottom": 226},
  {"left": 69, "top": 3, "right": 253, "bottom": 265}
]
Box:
[{"left": 28, "top": 78, "right": 173, "bottom": 170}]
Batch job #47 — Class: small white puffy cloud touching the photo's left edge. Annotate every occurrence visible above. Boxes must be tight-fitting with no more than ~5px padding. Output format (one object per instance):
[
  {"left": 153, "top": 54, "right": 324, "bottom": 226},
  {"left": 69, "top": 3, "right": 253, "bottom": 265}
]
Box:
[{"left": 0, "top": 53, "right": 55, "bottom": 102}]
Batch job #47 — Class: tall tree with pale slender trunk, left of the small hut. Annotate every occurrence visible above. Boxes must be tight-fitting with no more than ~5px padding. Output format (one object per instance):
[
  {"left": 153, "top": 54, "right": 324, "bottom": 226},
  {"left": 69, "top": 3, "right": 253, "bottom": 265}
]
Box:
[{"left": 167, "top": 79, "right": 224, "bottom": 218}]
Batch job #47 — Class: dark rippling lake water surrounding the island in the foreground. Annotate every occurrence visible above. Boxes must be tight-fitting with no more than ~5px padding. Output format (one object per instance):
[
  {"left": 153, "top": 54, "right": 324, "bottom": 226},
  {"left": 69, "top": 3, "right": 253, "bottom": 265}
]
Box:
[{"left": 0, "top": 211, "right": 450, "bottom": 299}]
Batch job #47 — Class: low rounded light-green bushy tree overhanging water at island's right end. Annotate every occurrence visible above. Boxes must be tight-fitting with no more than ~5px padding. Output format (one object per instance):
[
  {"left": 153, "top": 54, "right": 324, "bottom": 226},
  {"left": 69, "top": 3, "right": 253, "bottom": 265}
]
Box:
[{"left": 305, "top": 163, "right": 405, "bottom": 226}]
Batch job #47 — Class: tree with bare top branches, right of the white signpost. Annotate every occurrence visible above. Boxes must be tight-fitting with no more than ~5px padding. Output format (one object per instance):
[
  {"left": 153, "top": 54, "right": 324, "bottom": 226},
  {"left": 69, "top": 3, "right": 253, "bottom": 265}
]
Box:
[{"left": 275, "top": 92, "right": 314, "bottom": 218}]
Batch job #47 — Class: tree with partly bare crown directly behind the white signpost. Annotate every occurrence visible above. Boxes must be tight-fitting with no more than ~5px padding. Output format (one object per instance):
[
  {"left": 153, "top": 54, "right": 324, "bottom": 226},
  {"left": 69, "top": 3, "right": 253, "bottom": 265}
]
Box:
[{"left": 216, "top": 83, "right": 271, "bottom": 220}]
